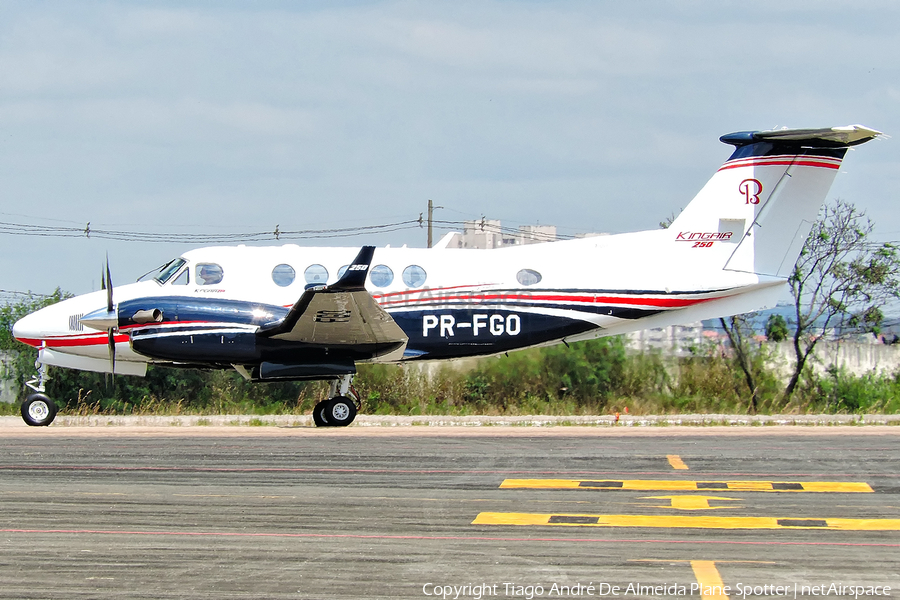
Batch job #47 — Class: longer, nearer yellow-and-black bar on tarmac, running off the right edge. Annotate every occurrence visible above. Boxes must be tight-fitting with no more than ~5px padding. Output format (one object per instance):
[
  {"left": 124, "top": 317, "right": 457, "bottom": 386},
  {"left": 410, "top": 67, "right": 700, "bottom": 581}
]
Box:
[{"left": 472, "top": 512, "right": 900, "bottom": 531}]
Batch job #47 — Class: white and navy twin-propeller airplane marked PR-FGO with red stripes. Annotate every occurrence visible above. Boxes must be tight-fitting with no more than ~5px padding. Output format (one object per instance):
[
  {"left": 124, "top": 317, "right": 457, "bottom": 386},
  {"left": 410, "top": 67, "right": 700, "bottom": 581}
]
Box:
[{"left": 13, "top": 125, "right": 880, "bottom": 426}]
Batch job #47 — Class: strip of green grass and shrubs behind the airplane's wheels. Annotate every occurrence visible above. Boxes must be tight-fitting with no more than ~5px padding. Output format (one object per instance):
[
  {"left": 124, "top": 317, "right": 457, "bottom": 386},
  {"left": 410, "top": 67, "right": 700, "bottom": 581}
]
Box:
[{"left": 0, "top": 338, "right": 900, "bottom": 426}]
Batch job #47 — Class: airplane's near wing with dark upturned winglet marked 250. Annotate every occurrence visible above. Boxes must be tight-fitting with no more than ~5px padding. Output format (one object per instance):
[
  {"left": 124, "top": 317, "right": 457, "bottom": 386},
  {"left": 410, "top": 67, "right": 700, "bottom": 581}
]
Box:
[{"left": 257, "top": 246, "right": 408, "bottom": 357}]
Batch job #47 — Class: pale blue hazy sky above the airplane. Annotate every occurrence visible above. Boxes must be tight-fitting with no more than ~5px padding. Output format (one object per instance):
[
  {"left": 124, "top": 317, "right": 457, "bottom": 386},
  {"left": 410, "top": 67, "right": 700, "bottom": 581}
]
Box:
[{"left": 0, "top": 0, "right": 900, "bottom": 293}]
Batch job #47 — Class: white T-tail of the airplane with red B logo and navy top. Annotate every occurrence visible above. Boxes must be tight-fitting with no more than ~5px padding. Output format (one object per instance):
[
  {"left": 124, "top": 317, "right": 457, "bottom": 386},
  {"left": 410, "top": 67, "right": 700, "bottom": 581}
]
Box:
[{"left": 669, "top": 125, "right": 880, "bottom": 277}]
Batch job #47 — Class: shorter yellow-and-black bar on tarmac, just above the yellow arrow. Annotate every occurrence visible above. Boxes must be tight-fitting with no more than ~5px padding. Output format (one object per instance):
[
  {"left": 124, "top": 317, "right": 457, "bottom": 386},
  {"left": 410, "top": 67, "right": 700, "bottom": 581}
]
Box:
[{"left": 500, "top": 479, "right": 874, "bottom": 493}]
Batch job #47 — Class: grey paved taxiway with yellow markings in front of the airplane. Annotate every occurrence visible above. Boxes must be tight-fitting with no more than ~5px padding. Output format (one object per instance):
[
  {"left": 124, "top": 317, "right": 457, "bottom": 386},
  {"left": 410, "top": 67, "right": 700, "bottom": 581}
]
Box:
[{"left": 0, "top": 427, "right": 900, "bottom": 599}]
